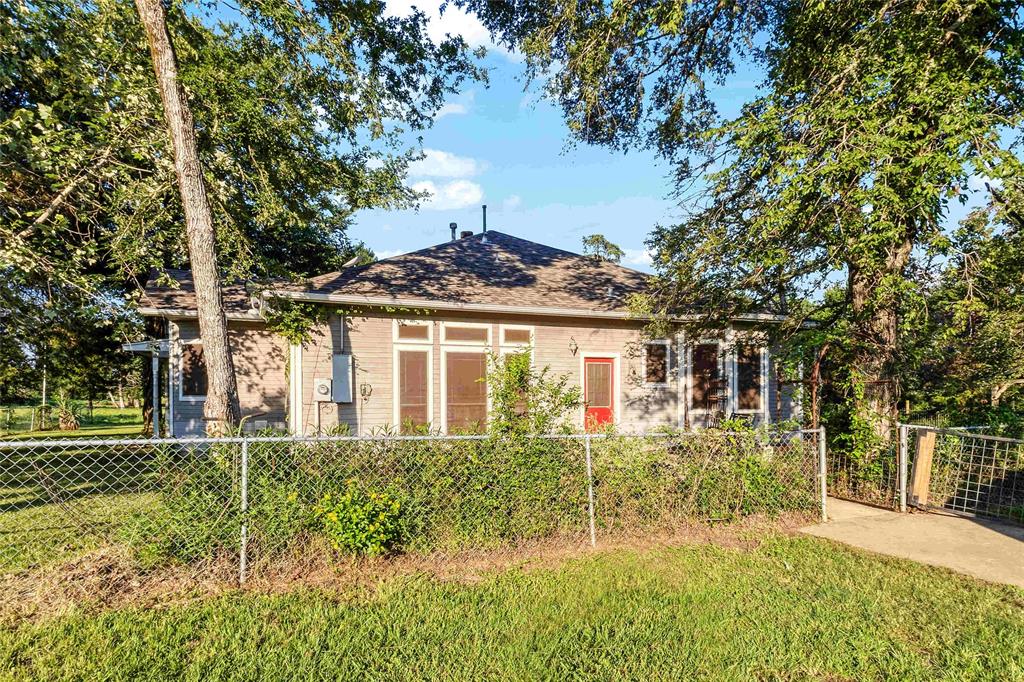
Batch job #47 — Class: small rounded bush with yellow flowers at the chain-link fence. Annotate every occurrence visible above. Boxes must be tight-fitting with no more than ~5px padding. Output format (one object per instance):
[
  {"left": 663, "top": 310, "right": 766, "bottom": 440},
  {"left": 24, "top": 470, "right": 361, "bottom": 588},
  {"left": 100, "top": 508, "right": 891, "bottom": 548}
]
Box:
[{"left": 313, "top": 480, "right": 404, "bottom": 556}]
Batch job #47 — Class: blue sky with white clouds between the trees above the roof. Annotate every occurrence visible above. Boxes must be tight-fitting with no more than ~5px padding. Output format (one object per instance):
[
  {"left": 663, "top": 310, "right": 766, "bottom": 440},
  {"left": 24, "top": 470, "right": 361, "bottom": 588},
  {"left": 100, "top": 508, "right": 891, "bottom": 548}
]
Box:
[{"left": 350, "top": 5, "right": 975, "bottom": 270}]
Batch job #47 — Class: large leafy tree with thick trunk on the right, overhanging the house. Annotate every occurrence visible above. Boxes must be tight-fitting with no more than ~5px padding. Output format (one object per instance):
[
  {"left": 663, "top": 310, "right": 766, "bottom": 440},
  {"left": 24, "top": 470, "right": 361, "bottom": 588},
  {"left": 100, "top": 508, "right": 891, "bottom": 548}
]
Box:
[{"left": 459, "top": 0, "right": 1024, "bottom": 447}]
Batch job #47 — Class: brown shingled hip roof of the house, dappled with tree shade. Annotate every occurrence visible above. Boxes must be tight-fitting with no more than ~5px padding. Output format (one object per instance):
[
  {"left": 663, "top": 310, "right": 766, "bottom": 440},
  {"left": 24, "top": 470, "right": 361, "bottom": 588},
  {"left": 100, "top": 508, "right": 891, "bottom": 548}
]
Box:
[{"left": 141, "top": 231, "right": 649, "bottom": 315}]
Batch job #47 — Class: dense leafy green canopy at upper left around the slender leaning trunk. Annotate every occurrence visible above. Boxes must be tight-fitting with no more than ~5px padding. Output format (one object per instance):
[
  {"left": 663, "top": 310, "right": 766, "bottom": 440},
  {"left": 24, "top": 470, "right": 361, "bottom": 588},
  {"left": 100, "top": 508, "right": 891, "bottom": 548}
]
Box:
[{"left": 0, "top": 0, "right": 483, "bottom": 311}]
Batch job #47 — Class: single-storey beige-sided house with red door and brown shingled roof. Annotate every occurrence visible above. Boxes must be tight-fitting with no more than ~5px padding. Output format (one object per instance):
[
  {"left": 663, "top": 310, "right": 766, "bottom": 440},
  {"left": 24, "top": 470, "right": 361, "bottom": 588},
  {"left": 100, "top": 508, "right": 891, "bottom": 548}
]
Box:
[{"left": 141, "top": 230, "right": 800, "bottom": 436}]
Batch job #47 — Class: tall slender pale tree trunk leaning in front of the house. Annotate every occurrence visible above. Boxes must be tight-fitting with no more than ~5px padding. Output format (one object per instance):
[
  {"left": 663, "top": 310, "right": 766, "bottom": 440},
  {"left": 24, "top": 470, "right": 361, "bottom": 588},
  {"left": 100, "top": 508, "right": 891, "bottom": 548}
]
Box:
[{"left": 135, "top": 0, "right": 240, "bottom": 435}]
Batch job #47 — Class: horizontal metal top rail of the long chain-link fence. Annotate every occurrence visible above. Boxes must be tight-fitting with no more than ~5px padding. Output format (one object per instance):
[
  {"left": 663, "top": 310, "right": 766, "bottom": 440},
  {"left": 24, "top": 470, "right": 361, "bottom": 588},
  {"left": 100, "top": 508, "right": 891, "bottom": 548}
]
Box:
[{"left": 0, "top": 429, "right": 820, "bottom": 450}]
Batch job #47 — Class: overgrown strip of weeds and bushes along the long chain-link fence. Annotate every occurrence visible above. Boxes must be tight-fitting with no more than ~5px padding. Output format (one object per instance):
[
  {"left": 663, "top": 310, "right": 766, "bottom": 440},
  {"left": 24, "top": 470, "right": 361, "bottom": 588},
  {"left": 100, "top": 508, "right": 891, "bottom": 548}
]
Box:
[{"left": 112, "top": 431, "right": 816, "bottom": 563}]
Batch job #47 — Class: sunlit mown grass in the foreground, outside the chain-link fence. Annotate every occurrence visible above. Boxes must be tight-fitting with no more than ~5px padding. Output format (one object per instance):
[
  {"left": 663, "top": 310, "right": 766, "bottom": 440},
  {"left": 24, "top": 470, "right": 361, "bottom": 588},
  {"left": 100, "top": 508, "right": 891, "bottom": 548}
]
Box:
[{"left": 0, "top": 536, "right": 1024, "bottom": 680}]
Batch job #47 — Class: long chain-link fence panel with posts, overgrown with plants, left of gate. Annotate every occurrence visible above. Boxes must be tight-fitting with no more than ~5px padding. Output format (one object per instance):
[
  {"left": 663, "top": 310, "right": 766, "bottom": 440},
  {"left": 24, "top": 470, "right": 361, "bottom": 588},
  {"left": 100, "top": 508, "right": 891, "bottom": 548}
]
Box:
[{"left": 0, "top": 431, "right": 823, "bottom": 579}]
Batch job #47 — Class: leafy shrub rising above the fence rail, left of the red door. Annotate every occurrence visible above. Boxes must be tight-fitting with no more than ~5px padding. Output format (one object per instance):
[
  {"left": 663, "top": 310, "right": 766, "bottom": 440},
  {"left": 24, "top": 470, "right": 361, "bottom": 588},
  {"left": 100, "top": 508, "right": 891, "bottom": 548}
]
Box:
[{"left": 487, "top": 348, "right": 583, "bottom": 435}]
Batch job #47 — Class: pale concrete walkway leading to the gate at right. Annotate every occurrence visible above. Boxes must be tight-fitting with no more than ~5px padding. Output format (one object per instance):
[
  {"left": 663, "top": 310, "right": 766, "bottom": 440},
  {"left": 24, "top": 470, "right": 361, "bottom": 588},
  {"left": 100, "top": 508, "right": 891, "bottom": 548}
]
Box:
[{"left": 801, "top": 498, "right": 1024, "bottom": 588}]
